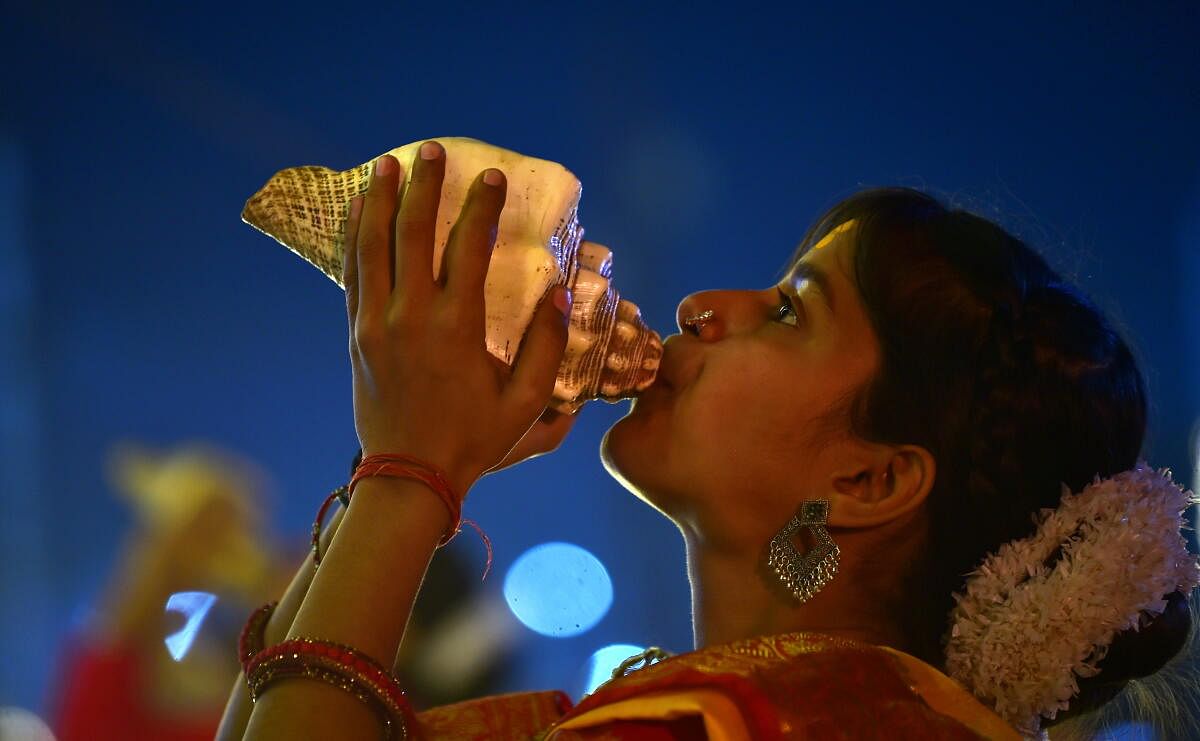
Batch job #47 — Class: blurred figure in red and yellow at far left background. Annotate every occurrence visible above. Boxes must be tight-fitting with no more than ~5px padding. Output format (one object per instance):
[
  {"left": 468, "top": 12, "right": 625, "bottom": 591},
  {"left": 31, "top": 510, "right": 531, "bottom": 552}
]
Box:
[{"left": 50, "top": 444, "right": 292, "bottom": 741}]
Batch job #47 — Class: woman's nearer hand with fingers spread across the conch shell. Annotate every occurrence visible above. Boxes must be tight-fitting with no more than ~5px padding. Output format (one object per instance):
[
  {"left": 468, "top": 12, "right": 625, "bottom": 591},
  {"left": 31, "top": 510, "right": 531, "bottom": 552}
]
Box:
[{"left": 343, "top": 141, "right": 570, "bottom": 494}]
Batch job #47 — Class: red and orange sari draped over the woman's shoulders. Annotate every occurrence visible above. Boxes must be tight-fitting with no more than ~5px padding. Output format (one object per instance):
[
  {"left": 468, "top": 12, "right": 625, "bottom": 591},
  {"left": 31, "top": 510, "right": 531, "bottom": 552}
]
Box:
[{"left": 418, "top": 633, "right": 1019, "bottom": 741}]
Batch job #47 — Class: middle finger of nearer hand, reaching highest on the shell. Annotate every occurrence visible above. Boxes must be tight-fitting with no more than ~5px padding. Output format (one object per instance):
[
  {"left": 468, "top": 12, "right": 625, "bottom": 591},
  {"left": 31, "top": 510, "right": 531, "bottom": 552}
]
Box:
[{"left": 395, "top": 141, "right": 446, "bottom": 302}]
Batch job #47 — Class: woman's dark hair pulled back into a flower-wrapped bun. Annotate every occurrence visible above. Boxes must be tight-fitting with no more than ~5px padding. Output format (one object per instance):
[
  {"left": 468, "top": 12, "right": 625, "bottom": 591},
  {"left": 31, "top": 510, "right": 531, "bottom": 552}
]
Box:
[{"left": 794, "top": 188, "right": 1190, "bottom": 719}]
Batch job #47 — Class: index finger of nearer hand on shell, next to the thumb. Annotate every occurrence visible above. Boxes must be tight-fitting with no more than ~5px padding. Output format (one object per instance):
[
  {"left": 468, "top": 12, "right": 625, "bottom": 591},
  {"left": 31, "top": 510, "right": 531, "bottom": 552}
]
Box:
[{"left": 445, "top": 168, "right": 508, "bottom": 327}]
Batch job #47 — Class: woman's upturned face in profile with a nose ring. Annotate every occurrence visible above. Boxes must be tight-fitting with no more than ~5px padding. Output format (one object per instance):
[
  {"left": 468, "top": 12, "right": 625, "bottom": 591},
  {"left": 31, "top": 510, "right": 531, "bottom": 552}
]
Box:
[{"left": 601, "top": 222, "right": 878, "bottom": 540}]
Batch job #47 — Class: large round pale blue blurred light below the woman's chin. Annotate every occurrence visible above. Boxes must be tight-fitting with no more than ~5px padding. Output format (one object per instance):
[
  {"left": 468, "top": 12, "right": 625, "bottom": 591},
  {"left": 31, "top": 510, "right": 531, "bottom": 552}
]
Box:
[{"left": 504, "top": 543, "right": 612, "bottom": 638}]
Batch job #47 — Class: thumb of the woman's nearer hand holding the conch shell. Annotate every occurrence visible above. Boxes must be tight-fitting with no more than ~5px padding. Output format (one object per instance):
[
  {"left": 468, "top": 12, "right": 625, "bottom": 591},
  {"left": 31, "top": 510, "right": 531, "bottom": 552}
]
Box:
[{"left": 506, "top": 285, "right": 571, "bottom": 418}]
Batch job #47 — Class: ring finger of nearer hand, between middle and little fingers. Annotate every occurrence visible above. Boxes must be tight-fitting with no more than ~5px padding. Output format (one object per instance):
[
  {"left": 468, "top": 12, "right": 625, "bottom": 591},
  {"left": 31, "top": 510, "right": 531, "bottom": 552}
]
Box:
[{"left": 354, "top": 155, "right": 400, "bottom": 321}]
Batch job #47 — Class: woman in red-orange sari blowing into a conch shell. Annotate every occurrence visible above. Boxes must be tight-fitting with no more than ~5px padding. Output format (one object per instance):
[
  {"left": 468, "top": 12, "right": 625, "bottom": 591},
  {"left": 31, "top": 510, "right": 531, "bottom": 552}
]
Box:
[{"left": 222, "top": 143, "right": 1196, "bottom": 739}]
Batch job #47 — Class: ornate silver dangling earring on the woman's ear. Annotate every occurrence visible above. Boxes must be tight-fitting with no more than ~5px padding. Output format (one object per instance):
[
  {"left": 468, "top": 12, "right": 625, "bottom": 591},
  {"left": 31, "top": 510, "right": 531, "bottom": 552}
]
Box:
[{"left": 767, "top": 499, "right": 841, "bottom": 604}]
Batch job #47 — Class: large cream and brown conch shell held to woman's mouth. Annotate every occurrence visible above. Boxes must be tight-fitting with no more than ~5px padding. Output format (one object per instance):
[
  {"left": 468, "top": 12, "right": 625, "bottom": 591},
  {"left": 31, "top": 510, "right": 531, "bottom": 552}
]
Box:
[{"left": 241, "top": 137, "right": 662, "bottom": 412}]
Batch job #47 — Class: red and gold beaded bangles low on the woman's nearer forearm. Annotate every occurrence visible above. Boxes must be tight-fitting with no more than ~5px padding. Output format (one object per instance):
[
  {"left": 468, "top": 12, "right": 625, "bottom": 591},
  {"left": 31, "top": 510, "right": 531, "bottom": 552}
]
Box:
[{"left": 246, "top": 638, "right": 414, "bottom": 739}]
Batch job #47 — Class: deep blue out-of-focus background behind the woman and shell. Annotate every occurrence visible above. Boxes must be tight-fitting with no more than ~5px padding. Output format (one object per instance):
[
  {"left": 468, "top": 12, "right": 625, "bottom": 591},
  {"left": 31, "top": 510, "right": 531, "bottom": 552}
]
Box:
[{"left": 0, "top": 1, "right": 1200, "bottom": 710}]
